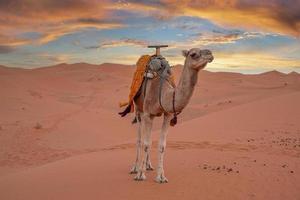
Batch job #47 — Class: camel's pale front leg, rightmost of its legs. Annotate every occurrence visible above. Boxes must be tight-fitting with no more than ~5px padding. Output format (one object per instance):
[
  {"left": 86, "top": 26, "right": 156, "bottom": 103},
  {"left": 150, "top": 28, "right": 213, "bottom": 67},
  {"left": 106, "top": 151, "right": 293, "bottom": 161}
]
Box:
[{"left": 155, "top": 114, "right": 171, "bottom": 183}]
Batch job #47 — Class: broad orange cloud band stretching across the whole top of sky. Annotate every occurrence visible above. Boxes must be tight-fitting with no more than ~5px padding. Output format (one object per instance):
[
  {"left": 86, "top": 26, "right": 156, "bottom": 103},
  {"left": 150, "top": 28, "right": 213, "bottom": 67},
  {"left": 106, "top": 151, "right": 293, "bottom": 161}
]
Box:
[{"left": 0, "top": 0, "right": 300, "bottom": 50}]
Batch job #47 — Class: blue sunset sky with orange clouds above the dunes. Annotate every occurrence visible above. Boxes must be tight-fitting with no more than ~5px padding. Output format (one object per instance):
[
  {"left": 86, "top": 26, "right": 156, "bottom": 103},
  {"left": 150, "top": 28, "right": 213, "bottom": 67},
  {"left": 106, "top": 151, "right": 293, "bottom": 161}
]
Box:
[{"left": 0, "top": 0, "right": 300, "bottom": 73}]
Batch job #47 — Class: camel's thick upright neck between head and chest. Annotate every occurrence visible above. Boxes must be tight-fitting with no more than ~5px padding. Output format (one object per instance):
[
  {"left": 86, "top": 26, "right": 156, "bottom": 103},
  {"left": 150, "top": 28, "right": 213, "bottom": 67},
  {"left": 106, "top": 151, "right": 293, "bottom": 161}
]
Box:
[{"left": 175, "top": 63, "right": 198, "bottom": 111}]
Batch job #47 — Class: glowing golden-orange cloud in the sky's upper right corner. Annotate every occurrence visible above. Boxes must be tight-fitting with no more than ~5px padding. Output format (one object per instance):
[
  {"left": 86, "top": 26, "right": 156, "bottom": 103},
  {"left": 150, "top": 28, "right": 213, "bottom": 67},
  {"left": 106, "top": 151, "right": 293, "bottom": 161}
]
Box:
[{"left": 190, "top": 0, "right": 300, "bottom": 36}]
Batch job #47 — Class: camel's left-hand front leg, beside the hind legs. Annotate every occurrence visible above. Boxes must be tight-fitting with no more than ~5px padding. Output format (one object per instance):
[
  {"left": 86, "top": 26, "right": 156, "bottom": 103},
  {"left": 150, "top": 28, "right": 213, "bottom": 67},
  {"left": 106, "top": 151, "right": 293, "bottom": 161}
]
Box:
[{"left": 134, "top": 114, "right": 153, "bottom": 181}]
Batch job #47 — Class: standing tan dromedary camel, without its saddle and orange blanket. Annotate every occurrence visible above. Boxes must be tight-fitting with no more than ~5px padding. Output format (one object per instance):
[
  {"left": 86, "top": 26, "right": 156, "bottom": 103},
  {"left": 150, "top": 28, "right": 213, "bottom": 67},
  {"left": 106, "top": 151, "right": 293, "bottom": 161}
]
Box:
[{"left": 131, "top": 48, "right": 214, "bottom": 183}]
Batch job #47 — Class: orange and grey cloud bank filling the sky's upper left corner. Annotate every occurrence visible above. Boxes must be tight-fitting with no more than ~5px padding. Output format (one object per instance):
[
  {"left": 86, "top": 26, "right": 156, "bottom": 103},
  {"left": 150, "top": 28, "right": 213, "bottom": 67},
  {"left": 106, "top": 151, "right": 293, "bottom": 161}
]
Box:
[{"left": 0, "top": 0, "right": 123, "bottom": 45}]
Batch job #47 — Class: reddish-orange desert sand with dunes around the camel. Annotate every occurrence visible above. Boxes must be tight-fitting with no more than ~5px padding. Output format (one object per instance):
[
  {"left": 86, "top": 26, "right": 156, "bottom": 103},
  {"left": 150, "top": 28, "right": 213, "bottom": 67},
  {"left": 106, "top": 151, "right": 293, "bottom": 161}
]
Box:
[{"left": 0, "top": 63, "right": 300, "bottom": 200}]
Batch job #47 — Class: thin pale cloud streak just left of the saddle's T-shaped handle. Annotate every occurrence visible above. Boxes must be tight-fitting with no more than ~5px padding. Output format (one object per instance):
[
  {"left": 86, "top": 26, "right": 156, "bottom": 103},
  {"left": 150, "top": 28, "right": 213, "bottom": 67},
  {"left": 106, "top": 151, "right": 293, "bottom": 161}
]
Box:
[{"left": 86, "top": 38, "right": 148, "bottom": 49}]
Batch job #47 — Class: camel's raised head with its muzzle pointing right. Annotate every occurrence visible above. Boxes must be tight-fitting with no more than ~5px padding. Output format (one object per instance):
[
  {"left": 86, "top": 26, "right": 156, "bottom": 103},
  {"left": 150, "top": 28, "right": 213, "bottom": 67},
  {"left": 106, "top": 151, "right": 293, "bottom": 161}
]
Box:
[{"left": 182, "top": 48, "right": 214, "bottom": 71}]
